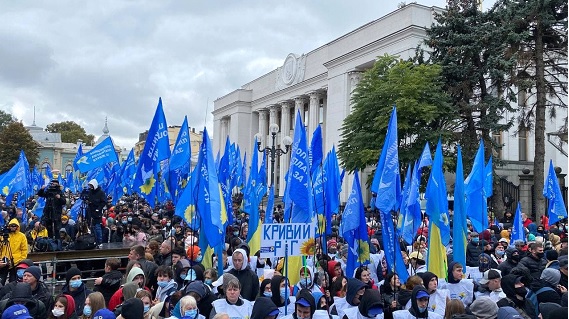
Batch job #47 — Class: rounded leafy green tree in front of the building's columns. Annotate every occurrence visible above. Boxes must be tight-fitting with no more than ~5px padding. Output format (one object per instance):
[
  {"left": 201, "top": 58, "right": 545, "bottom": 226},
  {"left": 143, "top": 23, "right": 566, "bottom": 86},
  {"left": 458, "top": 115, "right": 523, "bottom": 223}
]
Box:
[{"left": 338, "top": 55, "right": 456, "bottom": 179}]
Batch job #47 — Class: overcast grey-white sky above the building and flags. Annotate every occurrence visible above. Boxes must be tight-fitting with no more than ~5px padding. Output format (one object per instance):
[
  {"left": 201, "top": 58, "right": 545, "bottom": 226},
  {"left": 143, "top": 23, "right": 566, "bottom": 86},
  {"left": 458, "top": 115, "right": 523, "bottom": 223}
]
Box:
[{"left": 0, "top": 0, "right": 493, "bottom": 149}]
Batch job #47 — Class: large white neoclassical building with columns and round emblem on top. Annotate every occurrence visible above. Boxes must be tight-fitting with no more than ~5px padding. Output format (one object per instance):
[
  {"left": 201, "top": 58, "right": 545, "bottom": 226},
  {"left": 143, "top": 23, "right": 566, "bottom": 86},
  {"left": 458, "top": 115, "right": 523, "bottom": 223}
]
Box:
[{"left": 213, "top": 3, "right": 567, "bottom": 207}]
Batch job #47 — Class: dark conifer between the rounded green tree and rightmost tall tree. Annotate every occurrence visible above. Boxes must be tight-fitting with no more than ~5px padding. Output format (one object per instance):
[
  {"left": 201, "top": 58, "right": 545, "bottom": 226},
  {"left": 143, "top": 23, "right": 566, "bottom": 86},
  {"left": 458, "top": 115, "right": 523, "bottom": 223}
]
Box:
[{"left": 426, "top": 0, "right": 516, "bottom": 218}]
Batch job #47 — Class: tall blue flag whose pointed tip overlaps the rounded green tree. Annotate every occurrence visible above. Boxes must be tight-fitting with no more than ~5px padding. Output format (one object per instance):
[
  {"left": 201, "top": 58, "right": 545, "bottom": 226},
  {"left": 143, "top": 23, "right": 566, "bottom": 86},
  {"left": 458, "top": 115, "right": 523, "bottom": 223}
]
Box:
[{"left": 371, "top": 107, "right": 401, "bottom": 218}]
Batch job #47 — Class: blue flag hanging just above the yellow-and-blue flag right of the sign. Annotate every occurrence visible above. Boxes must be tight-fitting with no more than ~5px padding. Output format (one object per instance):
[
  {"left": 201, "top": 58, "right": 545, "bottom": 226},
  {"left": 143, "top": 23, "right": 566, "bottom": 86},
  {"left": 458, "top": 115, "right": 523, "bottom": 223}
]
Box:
[{"left": 425, "top": 139, "right": 450, "bottom": 245}]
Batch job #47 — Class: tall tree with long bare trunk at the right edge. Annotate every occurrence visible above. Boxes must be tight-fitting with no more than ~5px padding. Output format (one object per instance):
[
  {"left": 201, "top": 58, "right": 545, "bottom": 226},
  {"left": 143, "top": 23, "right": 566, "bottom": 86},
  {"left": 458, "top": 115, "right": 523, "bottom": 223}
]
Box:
[{"left": 493, "top": 0, "right": 568, "bottom": 216}]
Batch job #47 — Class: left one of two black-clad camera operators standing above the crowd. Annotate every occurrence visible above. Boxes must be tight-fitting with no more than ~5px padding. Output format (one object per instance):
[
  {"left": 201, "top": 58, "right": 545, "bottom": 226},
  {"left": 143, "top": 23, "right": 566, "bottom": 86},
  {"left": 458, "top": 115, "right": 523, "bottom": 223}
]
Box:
[{"left": 38, "top": 179, "right": 66, "bottom": 238}]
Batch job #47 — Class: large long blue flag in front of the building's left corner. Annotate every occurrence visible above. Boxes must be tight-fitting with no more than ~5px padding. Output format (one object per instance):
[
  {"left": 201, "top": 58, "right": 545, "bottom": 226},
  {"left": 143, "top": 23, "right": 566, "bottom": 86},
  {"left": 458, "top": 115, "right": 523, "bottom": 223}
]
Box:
[{"left": 194, "top": 127, "right": 227, "bottom": 247}]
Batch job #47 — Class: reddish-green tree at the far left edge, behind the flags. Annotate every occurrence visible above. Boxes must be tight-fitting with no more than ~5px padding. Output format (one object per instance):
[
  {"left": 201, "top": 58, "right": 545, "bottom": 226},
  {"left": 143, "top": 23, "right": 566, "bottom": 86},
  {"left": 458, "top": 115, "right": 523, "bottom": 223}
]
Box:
[{"left": 0, "top": 122, "right": 39, "bottom": 173}]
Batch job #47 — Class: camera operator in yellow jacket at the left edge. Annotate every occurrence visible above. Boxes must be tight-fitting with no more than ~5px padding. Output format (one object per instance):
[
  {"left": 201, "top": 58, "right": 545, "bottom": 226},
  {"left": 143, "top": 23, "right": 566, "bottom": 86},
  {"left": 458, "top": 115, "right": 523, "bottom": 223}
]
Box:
[{"left": 0, "top": 218, "right": 28, "bottom": 285}]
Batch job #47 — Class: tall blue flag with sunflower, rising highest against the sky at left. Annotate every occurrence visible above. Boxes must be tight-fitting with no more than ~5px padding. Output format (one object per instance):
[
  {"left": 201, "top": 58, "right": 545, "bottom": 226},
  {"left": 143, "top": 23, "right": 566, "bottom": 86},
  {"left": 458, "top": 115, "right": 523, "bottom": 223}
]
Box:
[{"left": 132, "top": 98, "right": 170, "bottom": 207}]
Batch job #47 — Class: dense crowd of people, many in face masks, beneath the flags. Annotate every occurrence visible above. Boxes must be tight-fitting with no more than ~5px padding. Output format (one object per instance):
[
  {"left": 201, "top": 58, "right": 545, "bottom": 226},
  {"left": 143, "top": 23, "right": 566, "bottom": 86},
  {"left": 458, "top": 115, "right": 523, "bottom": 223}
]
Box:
[{"left": 0, "top": 181, "right": 568, "bottom": 319}]
